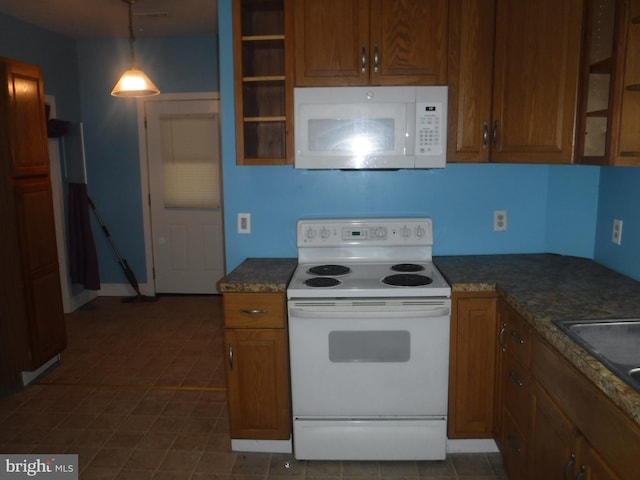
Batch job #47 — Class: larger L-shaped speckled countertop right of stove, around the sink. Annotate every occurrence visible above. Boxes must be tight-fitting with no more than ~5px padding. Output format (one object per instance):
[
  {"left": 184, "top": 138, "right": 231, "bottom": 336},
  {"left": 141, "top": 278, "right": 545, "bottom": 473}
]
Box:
[{"left": 434, "top": 254, "right": 640, "bottom": 425}]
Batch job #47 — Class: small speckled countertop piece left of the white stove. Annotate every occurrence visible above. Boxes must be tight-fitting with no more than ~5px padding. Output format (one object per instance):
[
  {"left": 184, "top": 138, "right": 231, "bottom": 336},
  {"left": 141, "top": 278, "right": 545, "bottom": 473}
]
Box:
[{"left": 218, "top": 258, "right": 298, "bottom": 293}]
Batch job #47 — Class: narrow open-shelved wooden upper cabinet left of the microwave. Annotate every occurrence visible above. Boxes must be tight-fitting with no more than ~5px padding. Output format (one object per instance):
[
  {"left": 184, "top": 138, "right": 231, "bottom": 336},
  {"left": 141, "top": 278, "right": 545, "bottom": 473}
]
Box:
[{"left": 233, "top": 0, "right": 293, "bottom": 165}]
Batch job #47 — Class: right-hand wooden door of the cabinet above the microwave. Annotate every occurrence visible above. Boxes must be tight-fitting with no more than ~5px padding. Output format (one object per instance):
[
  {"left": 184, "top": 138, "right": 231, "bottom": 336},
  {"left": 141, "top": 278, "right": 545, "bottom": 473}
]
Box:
[{"left": 369, "top": 0, "right": 449, "bottom": 85}]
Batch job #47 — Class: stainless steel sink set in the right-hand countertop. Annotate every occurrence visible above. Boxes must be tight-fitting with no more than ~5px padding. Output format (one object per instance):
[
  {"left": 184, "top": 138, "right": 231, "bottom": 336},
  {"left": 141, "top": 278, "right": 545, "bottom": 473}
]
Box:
[{"left": 554, "top": 318, "right": 640, "bottom": 392}]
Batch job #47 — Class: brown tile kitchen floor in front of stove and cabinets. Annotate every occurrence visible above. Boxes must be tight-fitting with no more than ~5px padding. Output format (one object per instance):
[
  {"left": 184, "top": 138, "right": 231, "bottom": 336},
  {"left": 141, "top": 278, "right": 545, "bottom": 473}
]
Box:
[{"left": 0, "top": 296, "right": 506, "bottom": 480}]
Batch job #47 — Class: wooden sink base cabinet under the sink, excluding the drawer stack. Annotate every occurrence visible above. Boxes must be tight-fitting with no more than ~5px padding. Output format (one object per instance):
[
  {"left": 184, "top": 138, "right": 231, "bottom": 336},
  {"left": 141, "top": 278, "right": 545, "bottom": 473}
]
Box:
[{"left": 527, "top": 336, "right": 640, "bottom": 480}]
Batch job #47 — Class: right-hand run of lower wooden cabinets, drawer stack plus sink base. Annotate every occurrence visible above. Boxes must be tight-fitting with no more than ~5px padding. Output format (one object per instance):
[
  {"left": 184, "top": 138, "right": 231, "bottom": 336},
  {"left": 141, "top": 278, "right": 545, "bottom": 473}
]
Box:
[{"left": 484, "top": 300, "right": 640, "bottom": 480}]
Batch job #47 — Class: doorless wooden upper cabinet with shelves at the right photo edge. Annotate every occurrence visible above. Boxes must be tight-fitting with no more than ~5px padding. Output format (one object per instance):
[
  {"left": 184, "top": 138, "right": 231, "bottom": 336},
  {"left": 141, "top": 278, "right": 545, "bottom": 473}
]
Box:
[{"left": 576, "top": 0, "right": 640, "bottom": 165}]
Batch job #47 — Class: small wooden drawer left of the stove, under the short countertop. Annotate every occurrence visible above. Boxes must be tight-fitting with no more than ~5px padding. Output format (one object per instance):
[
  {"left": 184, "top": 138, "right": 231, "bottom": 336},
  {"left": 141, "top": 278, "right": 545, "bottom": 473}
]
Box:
[{"left": 222, "top": 293, "right": 287, "bottom": 328}]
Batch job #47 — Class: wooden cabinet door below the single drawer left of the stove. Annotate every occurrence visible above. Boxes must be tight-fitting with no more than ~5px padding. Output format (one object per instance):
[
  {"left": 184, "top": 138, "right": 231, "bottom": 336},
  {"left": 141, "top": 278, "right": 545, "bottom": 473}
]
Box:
[{"left": 224, "top": 329, "right": 291, "bottom": 440}]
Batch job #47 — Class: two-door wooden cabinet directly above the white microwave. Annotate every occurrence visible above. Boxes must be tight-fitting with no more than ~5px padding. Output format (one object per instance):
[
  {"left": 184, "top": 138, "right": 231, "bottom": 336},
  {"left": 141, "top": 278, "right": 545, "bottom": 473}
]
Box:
[{"left": 294, "top": 0, "right": 449, "bottom": 87}]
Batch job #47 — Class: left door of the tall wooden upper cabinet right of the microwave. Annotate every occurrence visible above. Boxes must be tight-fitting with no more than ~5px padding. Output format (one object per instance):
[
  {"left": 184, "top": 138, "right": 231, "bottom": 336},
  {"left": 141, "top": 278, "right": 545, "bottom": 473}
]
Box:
[{"left": 447, "top": 0, "right": 495, "bottom": 162}]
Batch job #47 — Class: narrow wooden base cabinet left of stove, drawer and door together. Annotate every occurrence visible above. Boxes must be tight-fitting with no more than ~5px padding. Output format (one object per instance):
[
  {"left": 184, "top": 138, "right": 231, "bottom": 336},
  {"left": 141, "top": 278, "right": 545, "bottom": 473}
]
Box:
[{"left": 222, "top": 292, "right": 291, "bottom": 440}]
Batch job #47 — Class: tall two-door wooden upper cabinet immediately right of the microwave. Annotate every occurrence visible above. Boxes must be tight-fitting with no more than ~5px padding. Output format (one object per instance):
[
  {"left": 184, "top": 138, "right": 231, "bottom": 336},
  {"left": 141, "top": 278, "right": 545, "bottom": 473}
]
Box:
[{"left": 448, "top": 0, "right": 583, "bottom": 163}]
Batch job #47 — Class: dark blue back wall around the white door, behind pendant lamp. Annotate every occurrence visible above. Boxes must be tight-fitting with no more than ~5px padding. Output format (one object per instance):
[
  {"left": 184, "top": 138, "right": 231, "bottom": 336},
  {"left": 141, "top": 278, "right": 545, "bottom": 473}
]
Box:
[{"left": 77, "top": 36, "right": 218, "bottom": 283}]
